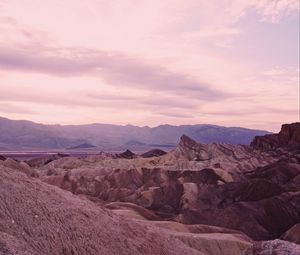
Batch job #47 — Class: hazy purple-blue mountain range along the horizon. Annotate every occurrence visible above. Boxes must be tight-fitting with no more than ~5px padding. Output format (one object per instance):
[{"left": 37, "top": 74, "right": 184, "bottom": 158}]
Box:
[{"left": 0, "top": 117, "right": 270, "bottom": 151}]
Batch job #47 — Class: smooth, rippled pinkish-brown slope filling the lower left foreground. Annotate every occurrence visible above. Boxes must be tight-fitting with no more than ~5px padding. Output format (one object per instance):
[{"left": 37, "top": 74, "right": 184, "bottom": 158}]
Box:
[{"left": 0, "top": 166, "right": 202, "bottom": 255}]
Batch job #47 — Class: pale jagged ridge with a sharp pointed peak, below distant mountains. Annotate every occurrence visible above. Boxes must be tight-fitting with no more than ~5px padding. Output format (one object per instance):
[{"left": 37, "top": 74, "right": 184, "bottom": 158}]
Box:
[{"left": 160, "top": 135, "right": 276, "bottom": 176}]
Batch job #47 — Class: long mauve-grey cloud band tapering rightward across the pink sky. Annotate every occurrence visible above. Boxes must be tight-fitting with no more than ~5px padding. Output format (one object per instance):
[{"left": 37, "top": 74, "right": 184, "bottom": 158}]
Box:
[{"left": 0, "top": 44, "right": 229, "bottom": 100}]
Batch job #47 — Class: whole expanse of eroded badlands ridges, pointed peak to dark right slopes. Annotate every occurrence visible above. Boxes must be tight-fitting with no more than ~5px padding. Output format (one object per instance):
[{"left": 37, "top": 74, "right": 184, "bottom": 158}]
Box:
[{"left": 34, "top": 125, "right": 300, "bottom": 240}]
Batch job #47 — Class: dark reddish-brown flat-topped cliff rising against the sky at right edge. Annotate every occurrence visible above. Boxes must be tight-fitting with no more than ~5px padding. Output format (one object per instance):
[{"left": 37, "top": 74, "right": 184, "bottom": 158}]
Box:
[{"left": 251, "top": 122, "right": 300, "bottom": 150}]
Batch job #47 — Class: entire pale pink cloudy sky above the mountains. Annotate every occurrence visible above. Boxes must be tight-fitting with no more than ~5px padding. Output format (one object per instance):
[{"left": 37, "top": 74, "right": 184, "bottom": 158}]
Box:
[{"left": 0, "top": 0, "right": 300, "bottom": 131}]
